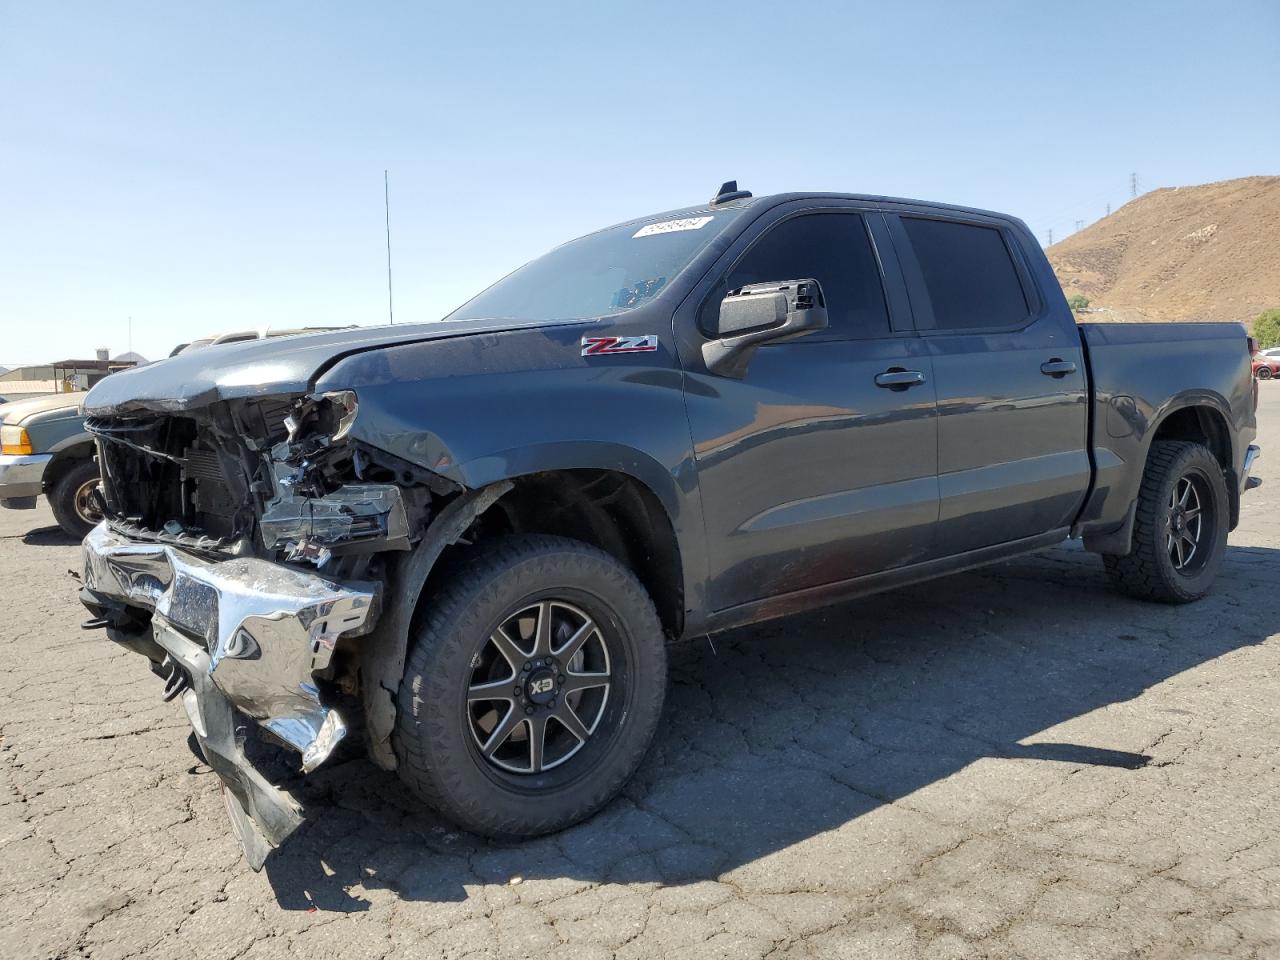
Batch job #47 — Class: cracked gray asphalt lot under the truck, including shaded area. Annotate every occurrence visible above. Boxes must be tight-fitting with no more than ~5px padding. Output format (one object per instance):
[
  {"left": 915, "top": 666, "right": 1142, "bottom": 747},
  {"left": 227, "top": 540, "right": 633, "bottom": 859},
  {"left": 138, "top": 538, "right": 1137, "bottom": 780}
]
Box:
[{"left": 0, "top": 384, "right": 1280, "bottom": 960}]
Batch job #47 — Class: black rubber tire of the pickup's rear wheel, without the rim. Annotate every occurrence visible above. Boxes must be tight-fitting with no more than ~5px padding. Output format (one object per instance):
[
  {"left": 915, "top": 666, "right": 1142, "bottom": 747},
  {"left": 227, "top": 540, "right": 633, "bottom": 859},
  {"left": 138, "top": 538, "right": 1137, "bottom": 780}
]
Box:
[{"left": 1102, "top": 440, "right": 1230, "bottom": 603}]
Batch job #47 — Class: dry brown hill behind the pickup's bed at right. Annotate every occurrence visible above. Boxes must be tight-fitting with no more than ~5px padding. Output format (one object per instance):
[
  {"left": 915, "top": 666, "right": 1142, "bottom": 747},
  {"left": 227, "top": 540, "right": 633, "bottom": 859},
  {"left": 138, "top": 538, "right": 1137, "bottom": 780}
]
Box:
[{"left": 1047, "top": 177, "right": 1280, "bottom": 330}]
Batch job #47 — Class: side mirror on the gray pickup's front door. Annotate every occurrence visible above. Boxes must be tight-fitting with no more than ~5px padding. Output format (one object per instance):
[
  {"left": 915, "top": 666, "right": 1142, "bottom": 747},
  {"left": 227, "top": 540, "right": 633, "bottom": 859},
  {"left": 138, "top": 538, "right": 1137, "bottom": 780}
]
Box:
[{"left": 703, "top": 280, "right": 827, "bottom": 379}]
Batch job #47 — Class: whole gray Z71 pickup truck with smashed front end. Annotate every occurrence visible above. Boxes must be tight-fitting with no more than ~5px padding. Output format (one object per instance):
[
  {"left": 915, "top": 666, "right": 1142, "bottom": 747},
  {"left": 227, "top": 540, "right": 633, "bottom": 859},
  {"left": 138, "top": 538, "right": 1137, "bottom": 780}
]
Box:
[{"left": 81, "top": 184, "right": 1258, "bottom": 867}]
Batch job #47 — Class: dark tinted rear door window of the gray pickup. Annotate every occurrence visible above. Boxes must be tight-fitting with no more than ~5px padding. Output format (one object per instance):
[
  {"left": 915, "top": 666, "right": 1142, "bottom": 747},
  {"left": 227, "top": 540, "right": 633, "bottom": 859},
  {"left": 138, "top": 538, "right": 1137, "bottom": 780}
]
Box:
[{"left": 901, "top": 216, "right": 1030, "bottom": 330}]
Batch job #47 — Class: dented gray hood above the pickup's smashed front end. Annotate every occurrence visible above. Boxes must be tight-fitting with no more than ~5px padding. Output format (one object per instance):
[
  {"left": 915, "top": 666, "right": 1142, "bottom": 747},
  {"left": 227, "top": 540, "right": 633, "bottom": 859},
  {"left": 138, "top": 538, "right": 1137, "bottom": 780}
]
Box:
[{"left": 84, "top": 320, "right": 575, "bottom": 416}]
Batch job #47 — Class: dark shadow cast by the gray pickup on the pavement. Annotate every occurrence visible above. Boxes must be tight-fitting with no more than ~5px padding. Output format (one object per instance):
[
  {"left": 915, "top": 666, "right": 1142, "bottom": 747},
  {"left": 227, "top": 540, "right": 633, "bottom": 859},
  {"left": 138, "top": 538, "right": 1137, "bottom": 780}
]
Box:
[{"left": 238, "top": 548, "right": 1280, "bottom": 911}]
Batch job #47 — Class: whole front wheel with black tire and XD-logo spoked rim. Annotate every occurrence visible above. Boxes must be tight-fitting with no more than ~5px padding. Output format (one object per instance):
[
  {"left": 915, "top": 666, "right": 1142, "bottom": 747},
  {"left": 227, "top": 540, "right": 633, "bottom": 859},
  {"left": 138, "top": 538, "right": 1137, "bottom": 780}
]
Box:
[{"left": 396, "top": 536, "right": 667, "bottom": 840}]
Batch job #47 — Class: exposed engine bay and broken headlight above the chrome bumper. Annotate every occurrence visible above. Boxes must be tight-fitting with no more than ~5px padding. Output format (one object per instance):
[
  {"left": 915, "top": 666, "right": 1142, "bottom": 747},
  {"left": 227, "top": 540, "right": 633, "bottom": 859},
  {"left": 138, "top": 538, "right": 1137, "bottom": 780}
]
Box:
[{"left": 86, "top": 390, "right": 458, "bottom": 568}]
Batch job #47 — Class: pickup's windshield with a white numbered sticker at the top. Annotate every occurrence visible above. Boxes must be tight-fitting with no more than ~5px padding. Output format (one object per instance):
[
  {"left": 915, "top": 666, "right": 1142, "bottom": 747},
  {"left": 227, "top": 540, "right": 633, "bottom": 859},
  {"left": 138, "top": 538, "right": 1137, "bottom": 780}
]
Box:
[{"left": 445, "top": 210, "right": 741, "bottom": 320}]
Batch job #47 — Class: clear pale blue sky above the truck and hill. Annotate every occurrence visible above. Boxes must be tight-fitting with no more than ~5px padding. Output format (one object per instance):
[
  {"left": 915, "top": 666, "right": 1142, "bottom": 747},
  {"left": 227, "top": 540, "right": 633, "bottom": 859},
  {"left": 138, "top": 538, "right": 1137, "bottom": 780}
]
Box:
[{"left": 0, "top": 0, "right": 1280, "bottom": 366}]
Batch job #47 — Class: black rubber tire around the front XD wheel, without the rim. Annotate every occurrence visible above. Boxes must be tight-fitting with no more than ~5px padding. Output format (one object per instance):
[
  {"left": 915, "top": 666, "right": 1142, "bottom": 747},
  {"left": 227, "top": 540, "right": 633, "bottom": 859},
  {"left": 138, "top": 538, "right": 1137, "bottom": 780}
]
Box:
[{"left": 393, "top": 535, "right": 667, "bottom": 840}]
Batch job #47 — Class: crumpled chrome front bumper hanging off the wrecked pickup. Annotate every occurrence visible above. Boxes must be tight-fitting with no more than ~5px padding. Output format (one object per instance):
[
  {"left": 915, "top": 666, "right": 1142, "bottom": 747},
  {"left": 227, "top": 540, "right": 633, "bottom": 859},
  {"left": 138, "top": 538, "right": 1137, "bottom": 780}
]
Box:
[{"left": 82, "top": 522, "right": 378, "bottom": 869}]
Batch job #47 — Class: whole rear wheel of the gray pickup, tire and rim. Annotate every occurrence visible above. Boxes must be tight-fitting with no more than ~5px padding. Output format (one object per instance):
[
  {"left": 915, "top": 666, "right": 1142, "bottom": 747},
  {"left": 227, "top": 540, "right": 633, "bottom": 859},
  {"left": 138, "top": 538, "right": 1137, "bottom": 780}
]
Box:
[{"left": 1102, "top": 440, "right": 1230, "bottom": 603}]
